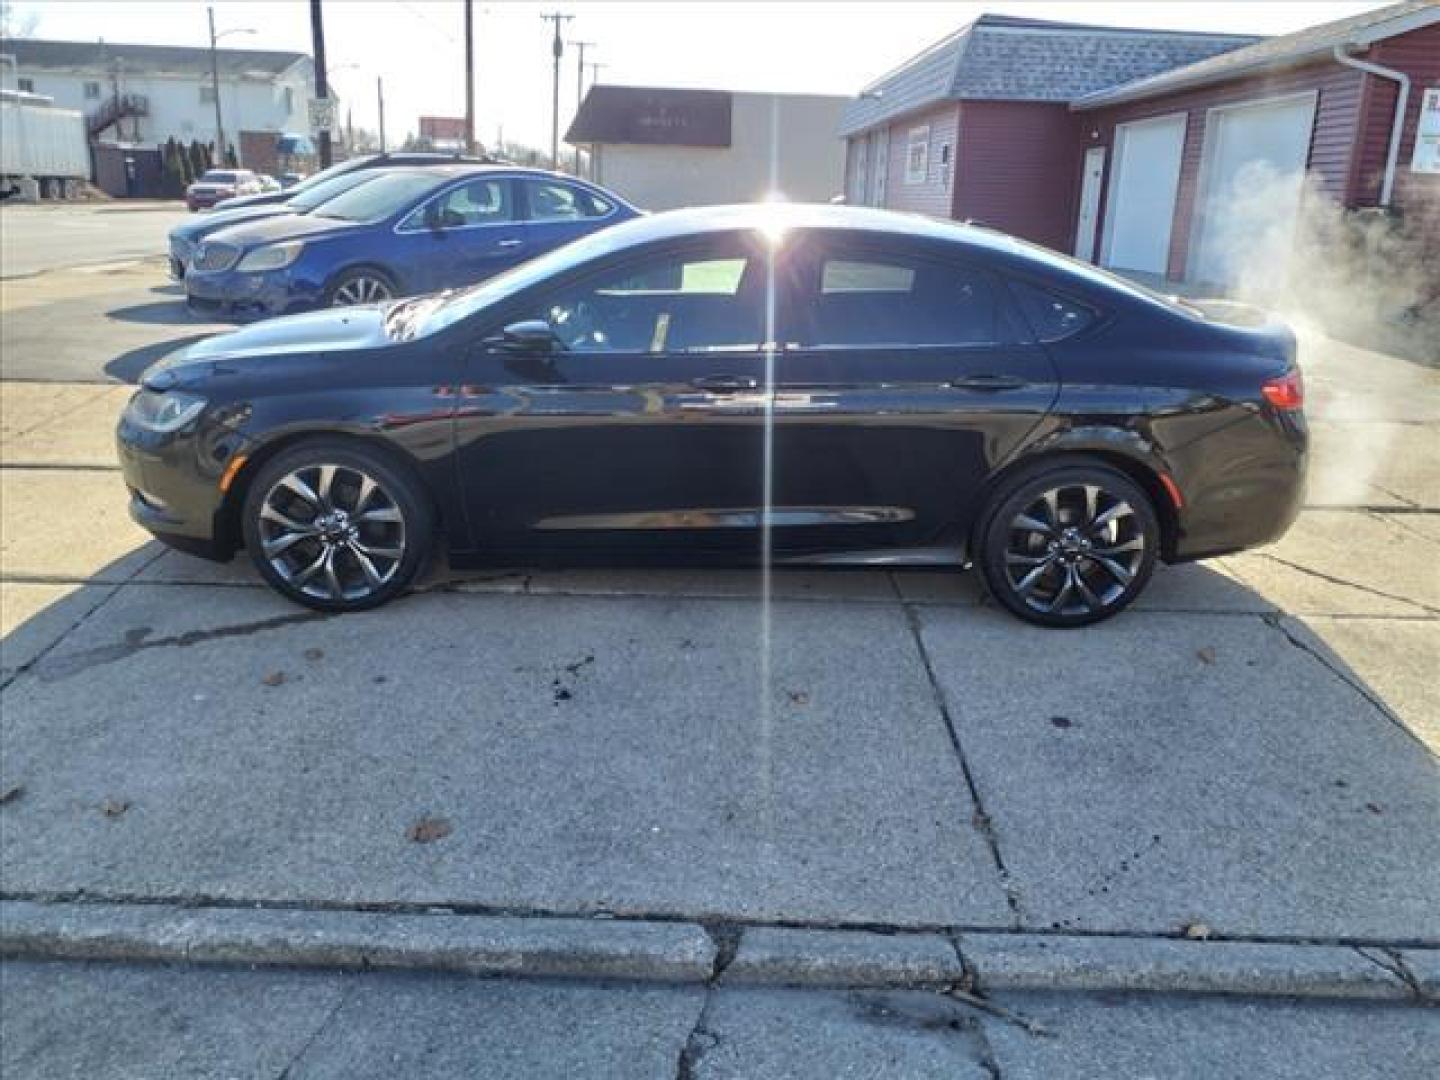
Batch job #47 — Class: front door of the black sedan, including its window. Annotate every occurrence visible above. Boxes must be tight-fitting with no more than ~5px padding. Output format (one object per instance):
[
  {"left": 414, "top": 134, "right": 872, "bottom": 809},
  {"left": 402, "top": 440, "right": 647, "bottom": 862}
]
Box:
[{"left": 456, "top": 235, "right": 783, "bottom": 553}]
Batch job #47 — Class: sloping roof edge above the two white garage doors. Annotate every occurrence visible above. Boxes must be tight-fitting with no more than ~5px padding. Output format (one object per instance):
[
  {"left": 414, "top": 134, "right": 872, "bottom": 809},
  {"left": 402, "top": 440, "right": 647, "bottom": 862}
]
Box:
[{"left": 1074, "top": 0, "right": 1440, "bottom": 109}]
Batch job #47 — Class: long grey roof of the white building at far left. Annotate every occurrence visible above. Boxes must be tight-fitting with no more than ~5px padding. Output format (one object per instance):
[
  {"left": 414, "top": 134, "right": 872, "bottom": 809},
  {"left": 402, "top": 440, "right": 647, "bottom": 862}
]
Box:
[{"left": 4, "top": 37, "right": 310, "bottom": 79}]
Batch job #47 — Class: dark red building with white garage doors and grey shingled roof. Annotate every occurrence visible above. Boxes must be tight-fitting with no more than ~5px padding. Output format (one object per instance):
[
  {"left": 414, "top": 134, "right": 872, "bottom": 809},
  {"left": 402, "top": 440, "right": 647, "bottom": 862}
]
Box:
[{"left": 842, "top": 0, "right": 1440, "bottom": 288}]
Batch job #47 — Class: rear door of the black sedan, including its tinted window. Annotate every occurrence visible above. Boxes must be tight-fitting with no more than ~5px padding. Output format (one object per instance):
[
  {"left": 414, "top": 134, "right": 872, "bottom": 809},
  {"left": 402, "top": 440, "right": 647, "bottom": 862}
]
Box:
[{"left": 775, "top": 233, "right": 1057, "bottom": 554}]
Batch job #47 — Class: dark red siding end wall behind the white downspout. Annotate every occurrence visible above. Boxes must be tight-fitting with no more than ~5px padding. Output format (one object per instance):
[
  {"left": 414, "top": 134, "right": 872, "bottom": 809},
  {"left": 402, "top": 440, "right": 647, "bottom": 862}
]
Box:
[{"left": 1348, "top": 26, "right": 1440, "bottom": 215}]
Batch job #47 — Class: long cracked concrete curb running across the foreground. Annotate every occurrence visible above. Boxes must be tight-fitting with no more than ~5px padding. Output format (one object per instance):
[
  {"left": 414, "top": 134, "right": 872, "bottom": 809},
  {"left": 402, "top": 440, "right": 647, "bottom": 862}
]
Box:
[{"left": 0, "top": 900, "right": 1440, "bottom": 1002}]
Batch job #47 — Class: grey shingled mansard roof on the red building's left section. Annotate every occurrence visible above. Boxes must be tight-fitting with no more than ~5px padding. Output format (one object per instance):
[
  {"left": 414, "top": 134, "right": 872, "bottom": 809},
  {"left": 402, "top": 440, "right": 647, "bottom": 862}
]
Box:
[{"left": 840, "top": 14, "right": 1261, "bottom": 135}]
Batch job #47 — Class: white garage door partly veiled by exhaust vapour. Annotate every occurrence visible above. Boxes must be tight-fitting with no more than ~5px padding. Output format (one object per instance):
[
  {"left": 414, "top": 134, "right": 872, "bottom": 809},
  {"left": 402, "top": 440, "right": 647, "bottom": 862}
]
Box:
[{"left": 1189, "top": 94, "right": 1315, "bottom": 285}]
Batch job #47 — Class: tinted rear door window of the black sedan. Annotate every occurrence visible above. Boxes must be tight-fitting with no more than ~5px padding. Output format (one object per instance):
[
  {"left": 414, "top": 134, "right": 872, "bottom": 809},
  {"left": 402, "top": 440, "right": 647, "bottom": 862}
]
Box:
[{"left": 796, "top": 253, "right": 1015, "bottom": 348}]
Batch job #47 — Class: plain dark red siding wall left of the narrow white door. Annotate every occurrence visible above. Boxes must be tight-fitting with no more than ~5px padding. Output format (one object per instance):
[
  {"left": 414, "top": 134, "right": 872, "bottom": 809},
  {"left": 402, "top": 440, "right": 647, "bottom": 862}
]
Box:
[{"left": 952, "top": 101, "right": 1081, "bottom": 252}]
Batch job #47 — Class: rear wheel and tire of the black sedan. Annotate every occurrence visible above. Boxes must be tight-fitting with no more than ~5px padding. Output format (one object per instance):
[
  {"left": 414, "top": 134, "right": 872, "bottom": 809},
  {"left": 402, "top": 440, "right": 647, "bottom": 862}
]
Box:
[{"left": 975, "top": 461, "right": 1161, "bottom": 626}]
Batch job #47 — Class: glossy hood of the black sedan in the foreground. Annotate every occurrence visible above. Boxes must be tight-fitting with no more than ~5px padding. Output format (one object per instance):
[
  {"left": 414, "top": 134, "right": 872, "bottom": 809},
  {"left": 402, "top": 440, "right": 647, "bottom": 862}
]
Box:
[{"left": 140, "top": 301, "right": 397, "bottom": 390}]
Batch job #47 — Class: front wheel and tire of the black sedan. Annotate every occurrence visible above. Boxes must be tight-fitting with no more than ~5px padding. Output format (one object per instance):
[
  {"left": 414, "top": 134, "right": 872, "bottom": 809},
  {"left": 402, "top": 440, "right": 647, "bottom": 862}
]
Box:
[{"left": 240, "top": 439, "right": 435, "bottom": 612}]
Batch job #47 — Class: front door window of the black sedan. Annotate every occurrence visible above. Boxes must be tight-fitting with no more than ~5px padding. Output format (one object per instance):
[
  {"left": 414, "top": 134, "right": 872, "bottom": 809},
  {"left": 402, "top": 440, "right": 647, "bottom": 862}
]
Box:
[{"left": 531, "top": 253, "right": 765, "bottom": 353}]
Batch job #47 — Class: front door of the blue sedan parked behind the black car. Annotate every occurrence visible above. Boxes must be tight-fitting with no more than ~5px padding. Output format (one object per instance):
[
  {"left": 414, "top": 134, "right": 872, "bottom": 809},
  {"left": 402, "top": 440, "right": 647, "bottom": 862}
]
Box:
[{"left": 395, "top": 176, "right": 530, "bottom": 292}]
